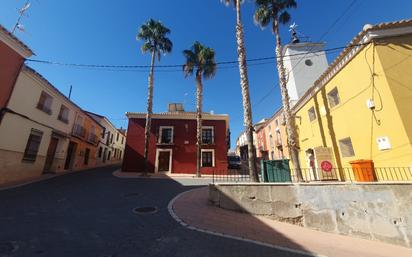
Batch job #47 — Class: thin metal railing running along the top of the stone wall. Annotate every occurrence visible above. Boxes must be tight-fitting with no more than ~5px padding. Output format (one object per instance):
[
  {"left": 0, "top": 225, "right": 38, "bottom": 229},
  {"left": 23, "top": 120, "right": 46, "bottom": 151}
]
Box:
[{"left": 213, "top": 167, "right": 412, "bottom": 183}]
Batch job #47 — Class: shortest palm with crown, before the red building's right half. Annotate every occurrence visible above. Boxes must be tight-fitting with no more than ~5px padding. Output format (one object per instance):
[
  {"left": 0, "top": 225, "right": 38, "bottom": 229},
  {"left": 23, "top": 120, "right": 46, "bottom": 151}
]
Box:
[{"left": 183, "top": 41, "right": 216, "bottom": 177}]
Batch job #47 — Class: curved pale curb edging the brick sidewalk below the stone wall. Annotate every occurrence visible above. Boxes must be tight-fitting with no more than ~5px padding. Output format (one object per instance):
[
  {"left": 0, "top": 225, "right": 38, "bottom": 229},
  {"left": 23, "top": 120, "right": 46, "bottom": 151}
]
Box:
[{"left": 167, "top": 188, "right": 327, "bottom": 257}]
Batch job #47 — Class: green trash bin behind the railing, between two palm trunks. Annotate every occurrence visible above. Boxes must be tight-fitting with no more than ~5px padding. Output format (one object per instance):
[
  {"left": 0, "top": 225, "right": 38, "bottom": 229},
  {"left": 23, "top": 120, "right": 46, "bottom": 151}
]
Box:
[{"left": 261, "top": 160, "right": 292, "bottom": 182}]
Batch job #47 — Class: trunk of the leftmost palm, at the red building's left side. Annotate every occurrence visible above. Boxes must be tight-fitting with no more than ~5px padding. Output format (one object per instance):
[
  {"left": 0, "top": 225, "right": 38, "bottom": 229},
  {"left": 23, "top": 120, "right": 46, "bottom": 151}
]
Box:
[{"left": 143, "top": 51, "right": 156, "bottom": 175}]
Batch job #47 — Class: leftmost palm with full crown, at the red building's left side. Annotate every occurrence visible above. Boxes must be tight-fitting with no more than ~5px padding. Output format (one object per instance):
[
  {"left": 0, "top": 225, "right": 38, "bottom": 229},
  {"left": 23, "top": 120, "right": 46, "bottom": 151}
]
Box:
[{"left": 136, "top": 19, "right": 173, "bottom": 175}]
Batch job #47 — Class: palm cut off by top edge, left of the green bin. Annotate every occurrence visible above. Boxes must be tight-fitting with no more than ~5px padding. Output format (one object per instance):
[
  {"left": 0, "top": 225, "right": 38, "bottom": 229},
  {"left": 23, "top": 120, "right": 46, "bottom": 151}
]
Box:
[{"left": 221, "top": 0, "right": 259, "bottom": 182}]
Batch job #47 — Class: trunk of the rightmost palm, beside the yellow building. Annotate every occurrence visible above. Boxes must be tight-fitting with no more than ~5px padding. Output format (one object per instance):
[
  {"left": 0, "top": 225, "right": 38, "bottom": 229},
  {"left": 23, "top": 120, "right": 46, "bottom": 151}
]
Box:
[{"left": 273, "top": 17, "right": 303, "bottom": 181}]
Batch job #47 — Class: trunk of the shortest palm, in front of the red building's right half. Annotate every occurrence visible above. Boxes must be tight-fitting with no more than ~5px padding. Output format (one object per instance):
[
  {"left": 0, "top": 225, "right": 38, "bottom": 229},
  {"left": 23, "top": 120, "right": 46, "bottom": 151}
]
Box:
[{"left": 196, "top": 71, "right": 203, "bottom": 177}]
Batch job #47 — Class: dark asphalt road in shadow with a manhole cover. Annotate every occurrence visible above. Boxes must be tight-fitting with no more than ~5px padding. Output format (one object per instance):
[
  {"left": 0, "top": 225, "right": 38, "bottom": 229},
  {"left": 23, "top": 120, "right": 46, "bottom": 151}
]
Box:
[{"left": 0, "top": 165, "right": 308, "bottom": 257}]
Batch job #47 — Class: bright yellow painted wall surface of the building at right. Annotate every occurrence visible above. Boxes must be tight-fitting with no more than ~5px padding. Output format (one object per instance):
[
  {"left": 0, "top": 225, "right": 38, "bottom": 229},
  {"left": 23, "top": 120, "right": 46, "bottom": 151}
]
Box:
[{"left": 296, "top": 36, "right": 412, "bottom": 180}]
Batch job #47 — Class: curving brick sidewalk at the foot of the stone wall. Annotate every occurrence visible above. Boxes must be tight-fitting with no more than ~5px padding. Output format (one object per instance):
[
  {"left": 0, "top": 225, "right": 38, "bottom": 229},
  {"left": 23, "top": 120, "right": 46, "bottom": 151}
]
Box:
[{"left": 169, "top": 187, "right": 412, "bottom": 257}]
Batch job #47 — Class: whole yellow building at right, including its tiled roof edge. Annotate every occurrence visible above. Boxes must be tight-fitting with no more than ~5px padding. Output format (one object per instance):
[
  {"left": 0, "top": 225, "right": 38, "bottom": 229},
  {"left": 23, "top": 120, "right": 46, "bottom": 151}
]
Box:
[{"left": 293, "top": 20, "right": 412, "bottom": 180}]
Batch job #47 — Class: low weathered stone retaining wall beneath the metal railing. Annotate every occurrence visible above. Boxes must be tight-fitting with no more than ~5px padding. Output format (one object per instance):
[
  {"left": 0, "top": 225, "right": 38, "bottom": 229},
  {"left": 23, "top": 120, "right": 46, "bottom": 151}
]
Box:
[{"left": 209, "top": 183, "right": 412, "bottom": 247}]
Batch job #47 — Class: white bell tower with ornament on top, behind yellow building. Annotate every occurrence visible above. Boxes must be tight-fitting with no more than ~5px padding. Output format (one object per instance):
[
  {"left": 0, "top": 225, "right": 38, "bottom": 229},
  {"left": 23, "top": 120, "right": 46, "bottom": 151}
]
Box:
[{"left": 282, "top": 23, "right": 328, "bottom": 106}]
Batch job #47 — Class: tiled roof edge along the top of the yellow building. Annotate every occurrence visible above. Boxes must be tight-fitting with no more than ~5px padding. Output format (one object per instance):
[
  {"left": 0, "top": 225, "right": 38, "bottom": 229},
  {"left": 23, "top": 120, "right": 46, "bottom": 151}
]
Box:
[{"left": 292, "top": 19, "right": 412, "bottom": 111}]
